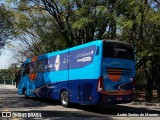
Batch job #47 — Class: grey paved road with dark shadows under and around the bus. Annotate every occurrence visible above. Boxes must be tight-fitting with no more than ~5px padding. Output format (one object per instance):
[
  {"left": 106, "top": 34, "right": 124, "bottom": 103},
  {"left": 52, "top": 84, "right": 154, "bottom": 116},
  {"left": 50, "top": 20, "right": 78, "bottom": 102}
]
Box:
[{"left": 0, "top": 85, "right": 160, "bottom": 120}]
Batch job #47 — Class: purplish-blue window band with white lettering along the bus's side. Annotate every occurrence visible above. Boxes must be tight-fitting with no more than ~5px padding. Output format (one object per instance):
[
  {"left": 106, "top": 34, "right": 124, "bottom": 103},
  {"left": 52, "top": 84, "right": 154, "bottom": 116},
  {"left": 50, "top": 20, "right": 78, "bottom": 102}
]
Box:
[{"left": 30, "top": 45, "right": 96, "bottom": 73}]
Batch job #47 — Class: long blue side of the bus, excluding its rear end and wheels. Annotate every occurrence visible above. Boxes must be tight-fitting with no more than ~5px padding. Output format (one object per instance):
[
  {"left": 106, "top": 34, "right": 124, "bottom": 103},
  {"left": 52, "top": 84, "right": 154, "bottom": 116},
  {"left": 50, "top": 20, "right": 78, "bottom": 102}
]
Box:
[{"left": 19, "top": 41, "right": 101, "bottom": 104}]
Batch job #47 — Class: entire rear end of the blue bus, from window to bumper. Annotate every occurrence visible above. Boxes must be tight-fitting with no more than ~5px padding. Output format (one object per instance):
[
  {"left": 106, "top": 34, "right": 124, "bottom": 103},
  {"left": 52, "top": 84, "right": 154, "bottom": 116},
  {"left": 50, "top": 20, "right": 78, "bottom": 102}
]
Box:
[{"left": 101, "top": 41, "right": 135, "bottom": 103}]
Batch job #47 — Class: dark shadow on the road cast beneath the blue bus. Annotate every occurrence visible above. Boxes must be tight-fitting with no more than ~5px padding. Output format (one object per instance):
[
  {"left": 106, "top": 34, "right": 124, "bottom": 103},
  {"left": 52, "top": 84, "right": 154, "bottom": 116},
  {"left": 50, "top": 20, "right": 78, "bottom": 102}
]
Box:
[{"left": 29, "top": 98, "right": 160, "bottom": 115}]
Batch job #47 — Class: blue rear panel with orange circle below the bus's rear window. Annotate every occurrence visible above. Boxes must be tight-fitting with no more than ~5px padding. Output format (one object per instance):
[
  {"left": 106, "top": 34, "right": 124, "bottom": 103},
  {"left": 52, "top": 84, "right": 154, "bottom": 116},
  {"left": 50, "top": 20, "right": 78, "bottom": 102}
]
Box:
[{"left": 103, "top": 58, "right": 135, "bottom": 91}]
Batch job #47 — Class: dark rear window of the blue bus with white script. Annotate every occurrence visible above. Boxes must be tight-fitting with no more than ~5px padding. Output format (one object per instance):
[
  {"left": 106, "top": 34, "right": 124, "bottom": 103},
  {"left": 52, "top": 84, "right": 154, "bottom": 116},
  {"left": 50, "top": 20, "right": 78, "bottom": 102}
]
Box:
[{"left": 103, "top": 41, "right": 134, "bottom": 60}]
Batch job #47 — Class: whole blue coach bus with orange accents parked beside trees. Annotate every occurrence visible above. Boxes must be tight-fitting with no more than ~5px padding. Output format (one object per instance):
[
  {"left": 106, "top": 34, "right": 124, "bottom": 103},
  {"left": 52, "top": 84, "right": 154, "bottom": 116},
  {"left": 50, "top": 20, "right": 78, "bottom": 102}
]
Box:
[{"left": 18, "top": 40, "right": 135, "bottom": 107}]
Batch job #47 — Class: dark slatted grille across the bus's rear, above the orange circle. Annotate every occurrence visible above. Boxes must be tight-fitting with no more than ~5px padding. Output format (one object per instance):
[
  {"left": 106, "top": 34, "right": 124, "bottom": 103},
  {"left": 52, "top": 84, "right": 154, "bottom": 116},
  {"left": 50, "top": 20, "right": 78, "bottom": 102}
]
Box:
[{"left": 106, "top": 68, "right": 132, "bottom": 75}]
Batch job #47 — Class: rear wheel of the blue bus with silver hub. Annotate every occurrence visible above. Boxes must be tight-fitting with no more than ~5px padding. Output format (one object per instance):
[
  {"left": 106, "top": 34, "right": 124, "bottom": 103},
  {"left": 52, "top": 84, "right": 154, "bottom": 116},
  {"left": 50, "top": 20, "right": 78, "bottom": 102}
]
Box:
[{"left": 61, "top": 91, "right": 69, "bottom": 107}]
